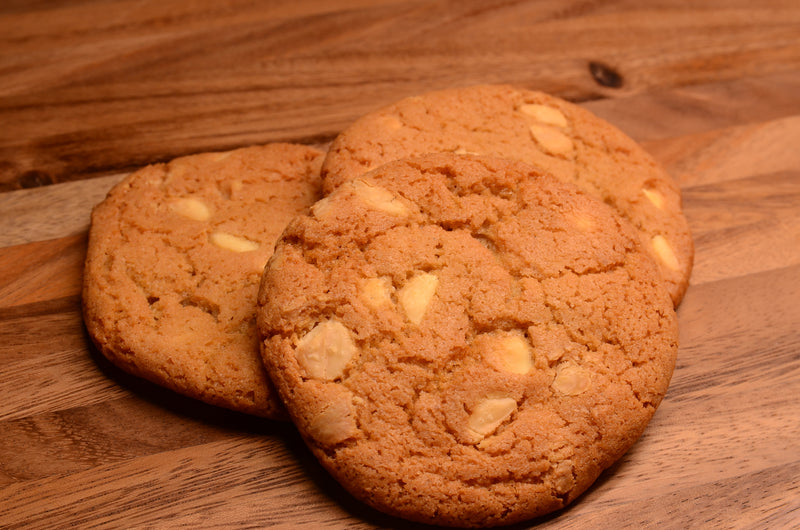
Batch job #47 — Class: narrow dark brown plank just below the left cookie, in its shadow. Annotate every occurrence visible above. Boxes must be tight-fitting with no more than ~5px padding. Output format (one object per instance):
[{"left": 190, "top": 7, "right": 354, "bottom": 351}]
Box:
[{"left": 0, "top": 392, "right": 296, "bottom": 487}]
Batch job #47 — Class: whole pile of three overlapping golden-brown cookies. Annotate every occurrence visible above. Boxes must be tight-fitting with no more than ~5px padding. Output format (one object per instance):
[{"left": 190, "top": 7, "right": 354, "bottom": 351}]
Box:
[{"left": 84, "top": 86, "right": 693, "bottom": 527}]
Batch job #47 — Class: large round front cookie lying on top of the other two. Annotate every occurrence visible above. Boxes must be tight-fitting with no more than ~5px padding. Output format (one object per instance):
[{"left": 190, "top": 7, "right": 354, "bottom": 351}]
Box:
[{"left": 258, "top": 154, "right": 677, "bottom": 526}]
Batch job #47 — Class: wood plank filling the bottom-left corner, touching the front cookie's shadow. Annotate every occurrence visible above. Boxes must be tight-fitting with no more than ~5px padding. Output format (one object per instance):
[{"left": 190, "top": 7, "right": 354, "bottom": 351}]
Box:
[{"left": 0, "top": 436, "right": 382, "bottom": 528}]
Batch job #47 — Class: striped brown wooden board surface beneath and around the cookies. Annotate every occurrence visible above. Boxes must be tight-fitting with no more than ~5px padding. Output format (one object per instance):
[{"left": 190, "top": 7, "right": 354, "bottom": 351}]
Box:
[{"left": 0, "top": 0, "right": 800, "bottom": 528}]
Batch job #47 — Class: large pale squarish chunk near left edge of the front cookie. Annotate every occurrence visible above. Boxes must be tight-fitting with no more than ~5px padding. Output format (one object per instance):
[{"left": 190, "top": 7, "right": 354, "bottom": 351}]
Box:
[{"left": 295, "top": 320, "right": 356, "bottom": 381}]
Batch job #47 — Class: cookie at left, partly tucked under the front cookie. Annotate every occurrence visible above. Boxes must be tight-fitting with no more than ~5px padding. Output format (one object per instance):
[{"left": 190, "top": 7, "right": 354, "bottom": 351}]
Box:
[{"left": 83, "top": 144, "right": 323, "bottom": 418}]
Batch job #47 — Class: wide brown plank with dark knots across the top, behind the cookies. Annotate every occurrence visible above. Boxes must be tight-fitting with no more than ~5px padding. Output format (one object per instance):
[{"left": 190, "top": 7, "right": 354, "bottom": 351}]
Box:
[{"left": 0, "top": 0, "right": 800, "bottom": 189}]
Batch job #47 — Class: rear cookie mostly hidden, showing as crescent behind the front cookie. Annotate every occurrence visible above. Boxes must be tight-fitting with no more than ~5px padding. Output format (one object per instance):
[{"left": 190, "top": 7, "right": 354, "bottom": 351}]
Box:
[{"left": 322, "top": 85, "right": 694, "bottom": 307}]
